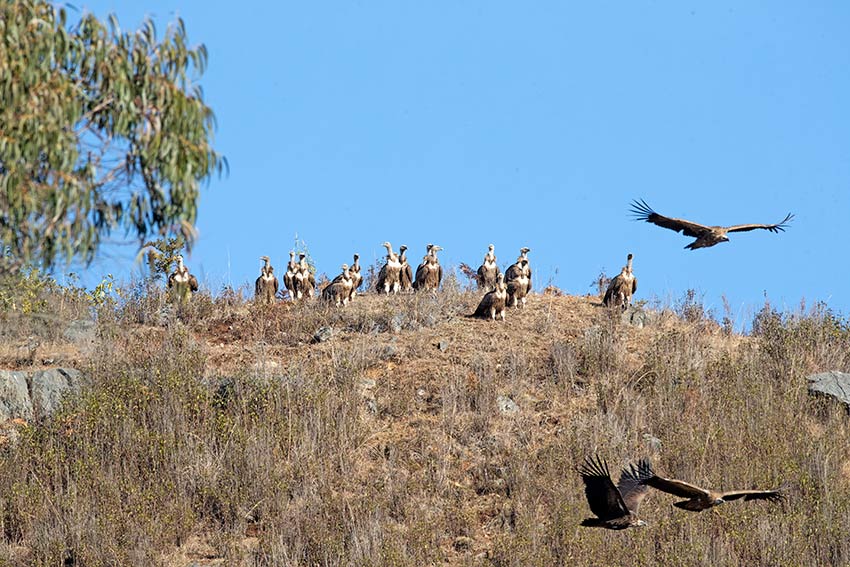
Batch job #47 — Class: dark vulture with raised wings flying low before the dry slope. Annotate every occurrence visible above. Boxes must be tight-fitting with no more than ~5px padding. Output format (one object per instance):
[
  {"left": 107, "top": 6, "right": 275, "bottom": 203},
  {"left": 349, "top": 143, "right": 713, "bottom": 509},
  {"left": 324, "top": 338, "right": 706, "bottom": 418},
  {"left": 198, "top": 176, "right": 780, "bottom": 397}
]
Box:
[{"left": 578, "top": 455, "right": 652, "bottom": 530}]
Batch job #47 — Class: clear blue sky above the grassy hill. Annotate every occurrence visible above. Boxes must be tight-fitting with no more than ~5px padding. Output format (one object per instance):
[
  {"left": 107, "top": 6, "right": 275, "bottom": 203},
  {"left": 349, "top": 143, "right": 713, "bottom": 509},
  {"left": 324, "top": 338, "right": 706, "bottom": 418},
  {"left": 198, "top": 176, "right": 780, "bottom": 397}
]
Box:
[{"left": 78, "top": 0, "right": 850, "bottom": 328}]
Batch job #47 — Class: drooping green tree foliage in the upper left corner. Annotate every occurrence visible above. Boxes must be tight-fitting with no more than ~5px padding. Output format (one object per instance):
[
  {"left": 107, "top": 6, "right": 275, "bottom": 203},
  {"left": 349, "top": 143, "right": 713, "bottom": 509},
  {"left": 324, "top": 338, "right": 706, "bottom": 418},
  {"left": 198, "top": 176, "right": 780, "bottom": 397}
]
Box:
[{"left": 0, "top": 0, "right": 226, "bottom": 267}]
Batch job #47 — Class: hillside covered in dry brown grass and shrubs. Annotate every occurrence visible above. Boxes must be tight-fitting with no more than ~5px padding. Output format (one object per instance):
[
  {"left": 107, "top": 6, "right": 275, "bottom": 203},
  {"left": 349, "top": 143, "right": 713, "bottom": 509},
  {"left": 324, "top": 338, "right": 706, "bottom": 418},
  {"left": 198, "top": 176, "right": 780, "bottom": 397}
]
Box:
[{"left": 0, "top": 272, "right": 850, "bottom": 566}]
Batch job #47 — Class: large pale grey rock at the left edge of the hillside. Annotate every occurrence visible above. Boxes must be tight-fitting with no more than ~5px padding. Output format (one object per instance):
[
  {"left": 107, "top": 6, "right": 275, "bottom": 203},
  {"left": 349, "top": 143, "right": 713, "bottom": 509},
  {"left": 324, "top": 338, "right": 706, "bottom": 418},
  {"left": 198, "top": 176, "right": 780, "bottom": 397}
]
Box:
[{"left": 0, "top": 368, "right": 84, "bottom": 422}]
